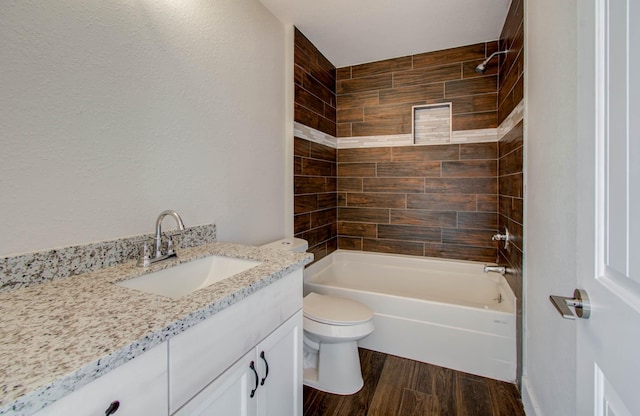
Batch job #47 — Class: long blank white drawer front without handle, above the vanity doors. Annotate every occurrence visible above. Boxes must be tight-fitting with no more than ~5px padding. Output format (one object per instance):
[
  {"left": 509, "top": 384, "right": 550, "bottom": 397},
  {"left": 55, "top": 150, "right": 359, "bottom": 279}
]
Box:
[{"left": 169, "top": 269, "right": 302, "bottom": 413}]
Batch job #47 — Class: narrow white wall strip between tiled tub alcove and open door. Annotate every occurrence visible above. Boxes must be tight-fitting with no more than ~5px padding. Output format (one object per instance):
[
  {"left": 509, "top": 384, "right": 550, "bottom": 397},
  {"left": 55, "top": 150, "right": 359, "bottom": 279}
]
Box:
[{"left": 523, "top": 0, "right": 578, "bottom": 416}]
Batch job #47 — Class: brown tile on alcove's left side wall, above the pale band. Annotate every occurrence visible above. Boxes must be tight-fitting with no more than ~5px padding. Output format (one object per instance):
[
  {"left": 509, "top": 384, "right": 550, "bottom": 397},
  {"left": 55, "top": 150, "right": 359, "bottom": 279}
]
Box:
[{"left": 293, "top": 28, "right": 336, "bottom": 136}]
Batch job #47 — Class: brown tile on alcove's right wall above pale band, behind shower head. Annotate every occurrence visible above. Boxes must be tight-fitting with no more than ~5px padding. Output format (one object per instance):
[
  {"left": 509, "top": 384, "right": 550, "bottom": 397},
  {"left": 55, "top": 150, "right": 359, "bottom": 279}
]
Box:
[{"left": 498, "top": 0, "right": 524, "bottom": 124}]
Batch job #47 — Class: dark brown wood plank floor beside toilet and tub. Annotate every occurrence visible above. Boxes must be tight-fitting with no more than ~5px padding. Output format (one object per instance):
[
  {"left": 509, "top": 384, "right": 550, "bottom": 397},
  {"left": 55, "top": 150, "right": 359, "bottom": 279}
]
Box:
[{"left": 304, "top": 349, "right": 525, "bottom": 416}]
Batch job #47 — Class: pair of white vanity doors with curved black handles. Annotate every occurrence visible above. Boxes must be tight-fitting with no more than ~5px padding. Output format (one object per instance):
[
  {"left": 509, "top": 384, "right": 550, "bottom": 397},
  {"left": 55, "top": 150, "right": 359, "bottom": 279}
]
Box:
[{"left": 175, "top": 311, "right": 302, "bottom": 416}]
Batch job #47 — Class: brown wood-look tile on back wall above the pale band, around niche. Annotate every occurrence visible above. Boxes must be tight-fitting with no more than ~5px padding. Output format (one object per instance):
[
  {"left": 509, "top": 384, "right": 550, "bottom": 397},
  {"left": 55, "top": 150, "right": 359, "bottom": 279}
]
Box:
[{"left": 336, "top": 41, "right": 498, "bottom": 137}]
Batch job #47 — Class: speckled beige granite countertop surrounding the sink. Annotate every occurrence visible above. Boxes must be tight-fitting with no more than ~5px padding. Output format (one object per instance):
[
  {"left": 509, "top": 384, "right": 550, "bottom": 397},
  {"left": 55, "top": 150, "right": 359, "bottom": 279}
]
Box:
[{"left": 0, "top": 243, "right": 313, "bottom": 415}]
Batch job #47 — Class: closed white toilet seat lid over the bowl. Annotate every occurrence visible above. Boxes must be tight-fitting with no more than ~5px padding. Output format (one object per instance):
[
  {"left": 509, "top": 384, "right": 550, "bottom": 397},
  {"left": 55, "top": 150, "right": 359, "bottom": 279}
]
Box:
[{"left": 302, "top": 292, "right": 373, "bottom": 325}]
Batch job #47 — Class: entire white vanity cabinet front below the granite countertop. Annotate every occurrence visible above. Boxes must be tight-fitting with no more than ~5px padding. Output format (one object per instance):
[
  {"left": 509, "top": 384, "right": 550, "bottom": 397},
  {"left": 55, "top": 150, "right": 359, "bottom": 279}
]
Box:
[{"left": 36, "top": 269, "right": 303, "bottom": 416}]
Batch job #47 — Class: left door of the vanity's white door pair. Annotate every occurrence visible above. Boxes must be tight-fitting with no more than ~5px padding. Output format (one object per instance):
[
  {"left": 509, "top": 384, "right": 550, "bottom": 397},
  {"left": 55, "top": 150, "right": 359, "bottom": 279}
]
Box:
[{"left": 175, "top": 350, "right": 258, "bottom": 416}]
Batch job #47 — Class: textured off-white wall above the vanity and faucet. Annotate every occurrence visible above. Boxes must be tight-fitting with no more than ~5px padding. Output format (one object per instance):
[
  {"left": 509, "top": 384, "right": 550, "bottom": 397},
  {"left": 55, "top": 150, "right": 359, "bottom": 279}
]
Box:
[{"left": 0, "top": 0, "right": 287, "bottom": 255}]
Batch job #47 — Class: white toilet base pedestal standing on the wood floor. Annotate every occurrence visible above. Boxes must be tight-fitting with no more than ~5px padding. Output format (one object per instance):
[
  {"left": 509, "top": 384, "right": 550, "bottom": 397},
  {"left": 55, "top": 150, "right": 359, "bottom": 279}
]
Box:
[{"left": 303, "top": 341, "right": 364, "bottom": 395}]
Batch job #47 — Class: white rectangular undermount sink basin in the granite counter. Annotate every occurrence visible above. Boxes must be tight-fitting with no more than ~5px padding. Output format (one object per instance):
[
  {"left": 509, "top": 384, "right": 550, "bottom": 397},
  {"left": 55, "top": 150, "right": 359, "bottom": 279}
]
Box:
[{"left": 116, "top": 256, "right": 261, "bottom": 299}]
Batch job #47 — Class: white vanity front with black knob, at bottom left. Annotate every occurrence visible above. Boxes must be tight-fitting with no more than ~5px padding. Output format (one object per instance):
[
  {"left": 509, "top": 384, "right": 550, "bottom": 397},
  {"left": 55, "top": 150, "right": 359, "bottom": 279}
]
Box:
[{"left": 36, "top": 342, "right": 169, "bottom": 416}]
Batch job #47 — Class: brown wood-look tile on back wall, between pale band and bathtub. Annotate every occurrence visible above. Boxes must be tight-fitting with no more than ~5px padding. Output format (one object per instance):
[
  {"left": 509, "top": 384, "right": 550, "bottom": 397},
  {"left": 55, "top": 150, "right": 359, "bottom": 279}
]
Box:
[{"left": 337, "top": 143, "right": 498, "bottom": 262}]
